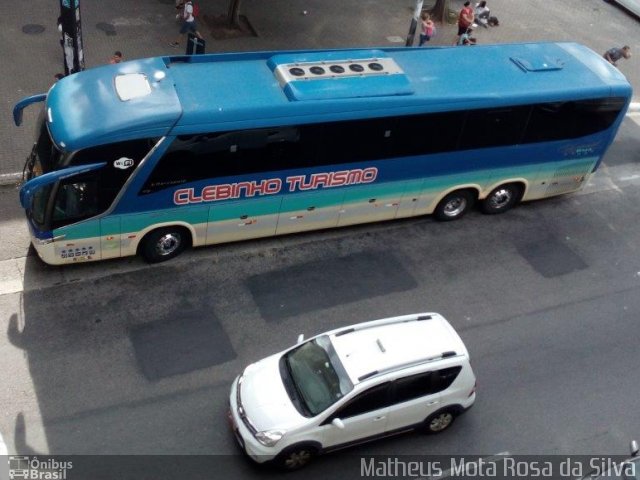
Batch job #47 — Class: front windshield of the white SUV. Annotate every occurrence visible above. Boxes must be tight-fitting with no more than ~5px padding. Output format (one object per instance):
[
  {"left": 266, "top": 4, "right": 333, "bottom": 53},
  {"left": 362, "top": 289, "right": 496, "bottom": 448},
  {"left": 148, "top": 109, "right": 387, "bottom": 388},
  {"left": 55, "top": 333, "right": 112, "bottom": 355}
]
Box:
[{"left": 283, "top": 335, "right": 353, "bottom": 416}]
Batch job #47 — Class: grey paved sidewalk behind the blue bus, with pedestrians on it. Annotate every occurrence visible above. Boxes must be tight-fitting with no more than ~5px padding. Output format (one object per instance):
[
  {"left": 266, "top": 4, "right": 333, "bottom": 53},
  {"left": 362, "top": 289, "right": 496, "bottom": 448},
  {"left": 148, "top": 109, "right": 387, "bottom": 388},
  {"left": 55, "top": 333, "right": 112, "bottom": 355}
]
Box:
[{"left": 0, "top": 0, "right": 640, "bottom": 183}]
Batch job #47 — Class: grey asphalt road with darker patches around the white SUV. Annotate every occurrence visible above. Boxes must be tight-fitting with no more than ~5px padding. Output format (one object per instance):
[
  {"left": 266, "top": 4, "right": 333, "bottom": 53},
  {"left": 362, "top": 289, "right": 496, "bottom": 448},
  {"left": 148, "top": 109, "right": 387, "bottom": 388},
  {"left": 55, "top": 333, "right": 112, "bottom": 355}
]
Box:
[{"left": 0, "top": 115, "right": 640, "bottom": 478}]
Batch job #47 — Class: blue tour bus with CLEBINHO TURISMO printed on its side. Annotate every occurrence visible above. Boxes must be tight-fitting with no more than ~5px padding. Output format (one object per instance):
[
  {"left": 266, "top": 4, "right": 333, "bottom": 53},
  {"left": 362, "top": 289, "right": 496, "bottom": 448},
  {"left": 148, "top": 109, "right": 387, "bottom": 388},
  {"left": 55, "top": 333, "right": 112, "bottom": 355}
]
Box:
[{"left": 14, "top": 43, "right": 632, "bottom": 264}]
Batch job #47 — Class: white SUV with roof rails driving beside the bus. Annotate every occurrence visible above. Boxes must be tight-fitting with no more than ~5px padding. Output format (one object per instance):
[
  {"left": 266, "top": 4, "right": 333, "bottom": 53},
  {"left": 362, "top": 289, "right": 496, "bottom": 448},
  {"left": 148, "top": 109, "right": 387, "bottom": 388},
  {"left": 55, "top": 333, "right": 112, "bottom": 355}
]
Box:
[{"left": 229, "top": 313, "right": 476, "bottom": 470}]
